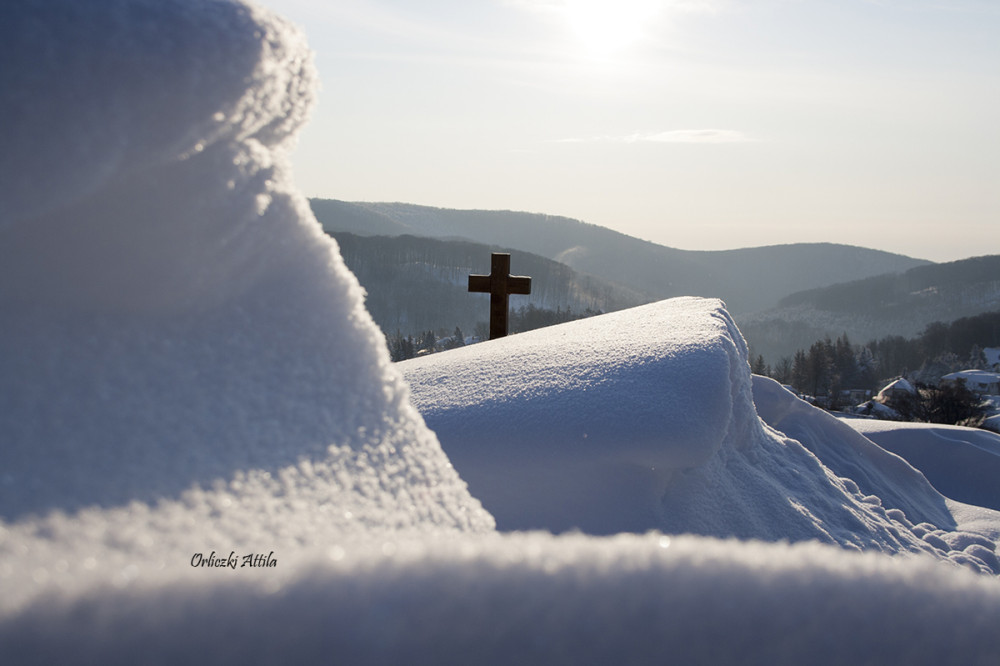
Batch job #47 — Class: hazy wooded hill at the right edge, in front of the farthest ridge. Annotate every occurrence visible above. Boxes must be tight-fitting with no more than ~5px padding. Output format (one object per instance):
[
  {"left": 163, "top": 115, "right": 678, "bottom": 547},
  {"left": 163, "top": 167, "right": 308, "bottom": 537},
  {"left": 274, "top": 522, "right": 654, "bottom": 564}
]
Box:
[{"left": 737, "top": 255, "right": 1000, "bottom": 361}]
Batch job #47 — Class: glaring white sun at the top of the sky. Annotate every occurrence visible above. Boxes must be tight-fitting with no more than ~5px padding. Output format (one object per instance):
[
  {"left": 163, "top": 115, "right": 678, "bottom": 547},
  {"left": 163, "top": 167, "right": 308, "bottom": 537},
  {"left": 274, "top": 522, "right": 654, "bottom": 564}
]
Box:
[{"left": 565, "top": 0, "right": 658, "bottom": 57}]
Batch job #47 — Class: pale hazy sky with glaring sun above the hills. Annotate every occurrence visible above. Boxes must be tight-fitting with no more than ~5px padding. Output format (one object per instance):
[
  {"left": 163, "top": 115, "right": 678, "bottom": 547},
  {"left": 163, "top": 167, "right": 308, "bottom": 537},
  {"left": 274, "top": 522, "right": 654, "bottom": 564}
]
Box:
[{"left": 254, "top": 0, "right": 1000, "bottom": 261}]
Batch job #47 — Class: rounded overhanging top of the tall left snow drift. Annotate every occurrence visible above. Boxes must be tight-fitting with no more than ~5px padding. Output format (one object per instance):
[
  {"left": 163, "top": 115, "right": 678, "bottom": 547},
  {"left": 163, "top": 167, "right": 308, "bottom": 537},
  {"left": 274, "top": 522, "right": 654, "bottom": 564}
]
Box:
[{"left": 0, "top": 0, "right": 316, "bottom": 226}]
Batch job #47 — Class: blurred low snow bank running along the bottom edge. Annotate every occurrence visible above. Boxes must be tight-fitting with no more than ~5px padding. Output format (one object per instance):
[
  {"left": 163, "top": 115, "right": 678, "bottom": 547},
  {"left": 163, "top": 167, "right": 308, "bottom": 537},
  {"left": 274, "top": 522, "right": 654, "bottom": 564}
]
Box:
[{"left": 0, "top": 534, "right": 1000, "bottom": 666}]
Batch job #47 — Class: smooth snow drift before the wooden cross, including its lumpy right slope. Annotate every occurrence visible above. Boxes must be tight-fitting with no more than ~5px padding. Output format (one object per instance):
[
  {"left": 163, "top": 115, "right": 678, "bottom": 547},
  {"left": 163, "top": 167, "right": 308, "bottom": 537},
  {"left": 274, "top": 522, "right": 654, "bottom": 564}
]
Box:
[{"left": 400, "top": 298, "right": 1000, "bottom": 573}]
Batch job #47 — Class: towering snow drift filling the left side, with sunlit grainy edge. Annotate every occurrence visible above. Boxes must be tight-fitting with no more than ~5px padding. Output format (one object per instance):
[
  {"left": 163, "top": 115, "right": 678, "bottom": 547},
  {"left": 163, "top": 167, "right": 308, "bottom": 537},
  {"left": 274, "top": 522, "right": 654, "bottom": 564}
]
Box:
[{"left": 0, "top": 0, "right": 493, "bottom": 604}]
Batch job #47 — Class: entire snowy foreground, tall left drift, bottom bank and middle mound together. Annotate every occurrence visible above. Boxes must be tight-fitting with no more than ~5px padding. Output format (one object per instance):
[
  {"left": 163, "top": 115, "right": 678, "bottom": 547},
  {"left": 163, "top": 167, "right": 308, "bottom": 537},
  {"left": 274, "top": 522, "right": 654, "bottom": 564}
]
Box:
[{"left": 0, "top": 0, "right": 1000, "bottom": 664}]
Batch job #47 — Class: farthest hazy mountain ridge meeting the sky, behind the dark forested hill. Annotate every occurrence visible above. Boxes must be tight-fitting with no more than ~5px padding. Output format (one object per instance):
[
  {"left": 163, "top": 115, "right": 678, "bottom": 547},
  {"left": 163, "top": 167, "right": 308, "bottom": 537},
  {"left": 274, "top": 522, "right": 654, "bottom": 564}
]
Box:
[{"left": 310, "top": 199, "right": 930, "bottom": 315}]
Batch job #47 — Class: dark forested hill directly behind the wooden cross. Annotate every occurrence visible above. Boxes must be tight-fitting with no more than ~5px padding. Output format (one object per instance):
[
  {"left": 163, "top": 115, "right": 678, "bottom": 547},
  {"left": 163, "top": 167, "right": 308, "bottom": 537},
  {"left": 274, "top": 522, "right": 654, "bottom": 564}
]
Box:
[{"left": 330, "top": 232, "right": 653, "bottom": 335}]
